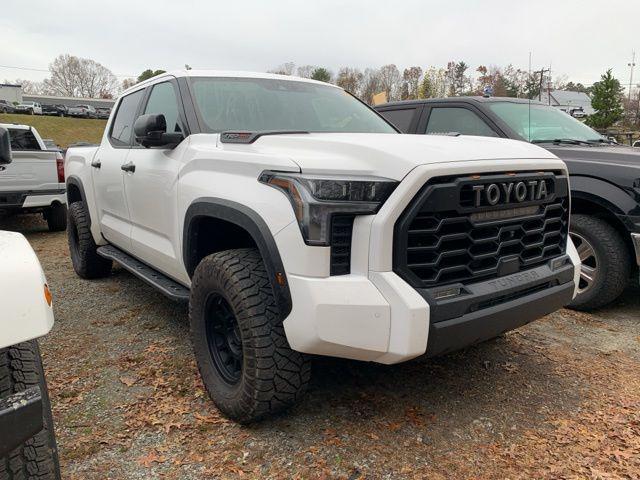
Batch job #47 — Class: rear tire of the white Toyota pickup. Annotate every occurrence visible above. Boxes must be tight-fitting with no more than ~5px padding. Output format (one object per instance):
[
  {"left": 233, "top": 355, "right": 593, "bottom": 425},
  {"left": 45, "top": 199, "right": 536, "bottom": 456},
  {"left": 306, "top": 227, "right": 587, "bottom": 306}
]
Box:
[{"left": 67, "top": 202, "right": 113, "bottom": 279}]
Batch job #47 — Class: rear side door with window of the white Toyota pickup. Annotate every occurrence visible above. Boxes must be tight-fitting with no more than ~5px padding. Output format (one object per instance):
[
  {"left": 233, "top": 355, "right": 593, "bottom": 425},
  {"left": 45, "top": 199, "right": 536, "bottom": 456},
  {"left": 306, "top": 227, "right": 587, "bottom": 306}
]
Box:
[{"left": 91, "top": 90, "right": 144, "bottom": 252}]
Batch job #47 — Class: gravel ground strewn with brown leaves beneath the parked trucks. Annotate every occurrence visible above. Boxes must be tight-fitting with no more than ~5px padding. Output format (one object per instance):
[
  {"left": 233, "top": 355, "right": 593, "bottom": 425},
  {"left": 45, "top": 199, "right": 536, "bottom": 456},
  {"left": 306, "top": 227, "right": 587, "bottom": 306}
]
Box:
[{"left": 0, "top": 217, "right": 640, "bottom": 479}]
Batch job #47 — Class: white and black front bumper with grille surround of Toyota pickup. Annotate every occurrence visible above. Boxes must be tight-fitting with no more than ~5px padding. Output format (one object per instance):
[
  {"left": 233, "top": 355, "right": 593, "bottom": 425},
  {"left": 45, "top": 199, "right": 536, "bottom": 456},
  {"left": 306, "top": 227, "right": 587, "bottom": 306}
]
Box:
[{"left": 275, "top": 160, "right": 580, "bottom": 364}]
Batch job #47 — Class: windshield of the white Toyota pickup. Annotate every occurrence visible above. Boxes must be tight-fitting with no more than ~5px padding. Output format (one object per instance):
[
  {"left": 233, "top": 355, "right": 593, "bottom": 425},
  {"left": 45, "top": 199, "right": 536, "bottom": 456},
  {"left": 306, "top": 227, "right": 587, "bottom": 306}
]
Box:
[{"left": 191, "top": 77, "right": 397, "bottom": 133}]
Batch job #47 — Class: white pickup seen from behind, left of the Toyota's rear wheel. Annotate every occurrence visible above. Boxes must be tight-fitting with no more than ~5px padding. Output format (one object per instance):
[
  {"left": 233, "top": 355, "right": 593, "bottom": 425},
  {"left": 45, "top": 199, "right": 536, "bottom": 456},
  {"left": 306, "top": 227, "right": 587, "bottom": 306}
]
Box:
[{"left": 0, "top": 123, "right": 67, "bottom": 232}]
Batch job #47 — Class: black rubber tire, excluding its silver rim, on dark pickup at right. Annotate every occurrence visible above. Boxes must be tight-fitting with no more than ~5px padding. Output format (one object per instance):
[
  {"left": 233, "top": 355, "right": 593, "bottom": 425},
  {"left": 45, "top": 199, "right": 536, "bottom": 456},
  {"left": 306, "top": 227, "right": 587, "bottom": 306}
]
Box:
[{"left": 569, "top": 214, "right": 631, "bottom": 311}]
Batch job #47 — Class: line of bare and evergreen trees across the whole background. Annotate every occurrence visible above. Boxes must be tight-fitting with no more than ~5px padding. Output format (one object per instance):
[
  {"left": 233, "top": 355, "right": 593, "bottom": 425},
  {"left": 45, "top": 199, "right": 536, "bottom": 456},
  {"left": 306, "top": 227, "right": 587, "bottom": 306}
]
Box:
[{"left": 5, "top": 54, "right": 640, "bottom": 128}]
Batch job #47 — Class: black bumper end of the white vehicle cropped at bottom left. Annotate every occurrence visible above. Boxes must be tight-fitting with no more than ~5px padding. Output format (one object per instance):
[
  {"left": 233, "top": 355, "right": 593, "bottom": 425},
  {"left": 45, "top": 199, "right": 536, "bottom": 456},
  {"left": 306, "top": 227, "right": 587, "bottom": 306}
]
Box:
[{"left": 0, "top": 387, "right": 43, "bottom": 458}]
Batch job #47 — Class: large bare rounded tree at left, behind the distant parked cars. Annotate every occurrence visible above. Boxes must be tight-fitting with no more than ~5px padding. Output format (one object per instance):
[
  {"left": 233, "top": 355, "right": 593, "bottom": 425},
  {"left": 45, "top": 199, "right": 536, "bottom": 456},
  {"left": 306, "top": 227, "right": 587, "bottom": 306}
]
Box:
[{"left": 44, "top": 54, "right": 120, "bottom": 98}]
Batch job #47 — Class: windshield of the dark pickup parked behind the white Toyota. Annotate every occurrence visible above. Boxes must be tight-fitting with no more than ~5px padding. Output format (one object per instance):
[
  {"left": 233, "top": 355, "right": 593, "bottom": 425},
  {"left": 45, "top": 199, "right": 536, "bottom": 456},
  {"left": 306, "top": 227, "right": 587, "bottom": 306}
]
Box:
[{"left": 488, "top": 102, "right": 604, "bottom": 143}]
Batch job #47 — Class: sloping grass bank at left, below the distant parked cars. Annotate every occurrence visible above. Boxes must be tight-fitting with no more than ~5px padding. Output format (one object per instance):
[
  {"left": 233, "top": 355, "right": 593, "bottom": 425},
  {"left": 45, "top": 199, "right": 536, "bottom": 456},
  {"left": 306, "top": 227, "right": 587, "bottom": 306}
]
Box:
[{"left": 0, "top": 114, "right": 107, "bottom": 148}]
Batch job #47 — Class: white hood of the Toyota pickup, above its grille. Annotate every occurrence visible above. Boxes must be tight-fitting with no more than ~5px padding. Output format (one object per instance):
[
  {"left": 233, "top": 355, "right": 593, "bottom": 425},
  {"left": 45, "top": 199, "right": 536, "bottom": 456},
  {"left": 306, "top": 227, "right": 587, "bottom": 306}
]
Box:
[{"left": 222, "top": 133, "right": 556, "bottom": 180}]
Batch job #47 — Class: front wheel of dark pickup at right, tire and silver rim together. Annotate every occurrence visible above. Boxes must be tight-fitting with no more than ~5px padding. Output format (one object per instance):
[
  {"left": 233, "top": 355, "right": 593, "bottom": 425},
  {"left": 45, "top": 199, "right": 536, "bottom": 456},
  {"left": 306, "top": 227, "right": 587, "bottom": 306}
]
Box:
[{"left": 569, "top": 214, "right": 631, "bottom": 310}]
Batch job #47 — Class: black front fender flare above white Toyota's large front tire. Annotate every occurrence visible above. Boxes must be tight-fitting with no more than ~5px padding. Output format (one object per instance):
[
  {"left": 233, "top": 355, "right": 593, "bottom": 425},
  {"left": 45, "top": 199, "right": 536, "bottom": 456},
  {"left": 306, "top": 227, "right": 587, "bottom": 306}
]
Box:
[{"left": 182, "top": 197, "right": 292, "bottom": 319}]
